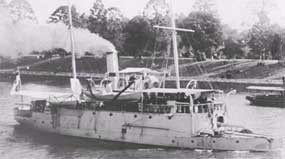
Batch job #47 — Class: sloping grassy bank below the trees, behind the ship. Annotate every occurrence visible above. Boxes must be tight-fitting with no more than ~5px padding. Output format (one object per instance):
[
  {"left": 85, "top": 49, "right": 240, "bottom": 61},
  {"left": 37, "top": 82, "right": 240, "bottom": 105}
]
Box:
[{"left": 2, "top": 56, "right": 285, "bottom": 84}]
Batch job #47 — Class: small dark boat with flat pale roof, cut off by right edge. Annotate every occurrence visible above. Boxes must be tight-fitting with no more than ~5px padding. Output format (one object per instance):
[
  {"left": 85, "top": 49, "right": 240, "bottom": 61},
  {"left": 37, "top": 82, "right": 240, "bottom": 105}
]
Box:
[{"left": 246, "top": 86, "right": 285, "bottom": 107}]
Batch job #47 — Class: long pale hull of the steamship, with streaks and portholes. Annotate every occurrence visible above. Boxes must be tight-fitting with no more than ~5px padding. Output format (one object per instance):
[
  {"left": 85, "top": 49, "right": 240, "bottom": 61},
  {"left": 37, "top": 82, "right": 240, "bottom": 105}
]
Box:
[{"left": 15, "top": 109, "right": 278, "bottom": 151}]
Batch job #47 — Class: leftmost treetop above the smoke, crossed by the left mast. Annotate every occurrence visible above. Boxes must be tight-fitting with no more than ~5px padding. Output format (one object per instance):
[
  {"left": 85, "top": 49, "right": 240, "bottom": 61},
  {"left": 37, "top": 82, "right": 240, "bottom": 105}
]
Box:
[{"left": 48, "top": 5, "right": 87, "bottom": 28}]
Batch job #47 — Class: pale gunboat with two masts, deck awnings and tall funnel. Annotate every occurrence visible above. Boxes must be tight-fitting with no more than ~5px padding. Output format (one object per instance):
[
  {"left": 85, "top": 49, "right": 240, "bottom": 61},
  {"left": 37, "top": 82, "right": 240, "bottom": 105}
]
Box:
[{"left": 12, "top": 0, "right": 280, "bottom": 151}]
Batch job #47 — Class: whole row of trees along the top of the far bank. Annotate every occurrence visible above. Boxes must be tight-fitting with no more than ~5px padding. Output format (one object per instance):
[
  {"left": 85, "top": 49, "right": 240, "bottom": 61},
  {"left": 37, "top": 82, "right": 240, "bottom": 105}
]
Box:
[{"left": 44, "top": 0, "right": 285, "bottom": 60}]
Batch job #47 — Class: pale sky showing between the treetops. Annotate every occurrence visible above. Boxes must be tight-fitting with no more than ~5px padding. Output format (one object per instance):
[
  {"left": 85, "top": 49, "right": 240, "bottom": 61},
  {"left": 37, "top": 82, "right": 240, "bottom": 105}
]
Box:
[{"left": 7, "top": 0, "right": 285, "bottom": 30}]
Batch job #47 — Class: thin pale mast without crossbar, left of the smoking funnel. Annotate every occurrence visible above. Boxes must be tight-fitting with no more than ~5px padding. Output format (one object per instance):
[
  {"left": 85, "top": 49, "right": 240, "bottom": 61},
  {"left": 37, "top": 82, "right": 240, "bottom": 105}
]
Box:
[{"left": 68, "top": 1, "right": 77, "bottom": 79}]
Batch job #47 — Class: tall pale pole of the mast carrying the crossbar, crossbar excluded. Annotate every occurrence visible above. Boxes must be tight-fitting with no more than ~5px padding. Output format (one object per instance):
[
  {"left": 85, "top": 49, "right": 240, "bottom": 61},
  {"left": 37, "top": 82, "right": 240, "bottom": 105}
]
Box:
[{"left": 170, "top": 0, "right": 180, "bottom": 89}]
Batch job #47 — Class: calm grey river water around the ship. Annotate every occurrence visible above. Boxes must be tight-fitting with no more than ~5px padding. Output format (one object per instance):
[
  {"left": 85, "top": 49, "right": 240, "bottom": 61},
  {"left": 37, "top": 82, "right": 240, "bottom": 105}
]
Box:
[{"left": 0, "top": 82, "right": 285, "bottom": 159}]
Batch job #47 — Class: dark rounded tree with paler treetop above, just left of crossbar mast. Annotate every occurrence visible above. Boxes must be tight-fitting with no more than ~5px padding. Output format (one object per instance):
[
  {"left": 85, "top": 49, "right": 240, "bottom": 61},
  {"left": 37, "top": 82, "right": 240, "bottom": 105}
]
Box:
[{"left": 120, "top": 0, "right": 171, "bottom": 57}]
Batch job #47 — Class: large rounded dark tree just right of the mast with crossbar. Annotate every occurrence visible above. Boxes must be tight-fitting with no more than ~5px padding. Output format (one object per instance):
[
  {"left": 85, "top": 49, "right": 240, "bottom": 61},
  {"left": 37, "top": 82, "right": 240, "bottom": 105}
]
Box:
[{"left": 178, "top": 11, "right": 223, "bottom": 58}]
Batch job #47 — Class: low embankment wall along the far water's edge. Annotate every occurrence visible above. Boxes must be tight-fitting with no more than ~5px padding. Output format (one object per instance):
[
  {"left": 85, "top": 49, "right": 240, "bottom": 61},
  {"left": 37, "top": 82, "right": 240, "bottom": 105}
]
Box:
[{"left": 0, "top": 69, "right": 283, "bottom": 92}]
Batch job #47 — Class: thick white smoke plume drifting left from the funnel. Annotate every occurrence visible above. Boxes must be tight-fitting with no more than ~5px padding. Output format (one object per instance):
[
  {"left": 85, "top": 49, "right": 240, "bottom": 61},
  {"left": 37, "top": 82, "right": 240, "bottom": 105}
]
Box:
[{"left": 0, "top": 6, "right": 115, "bottom": 58}]
